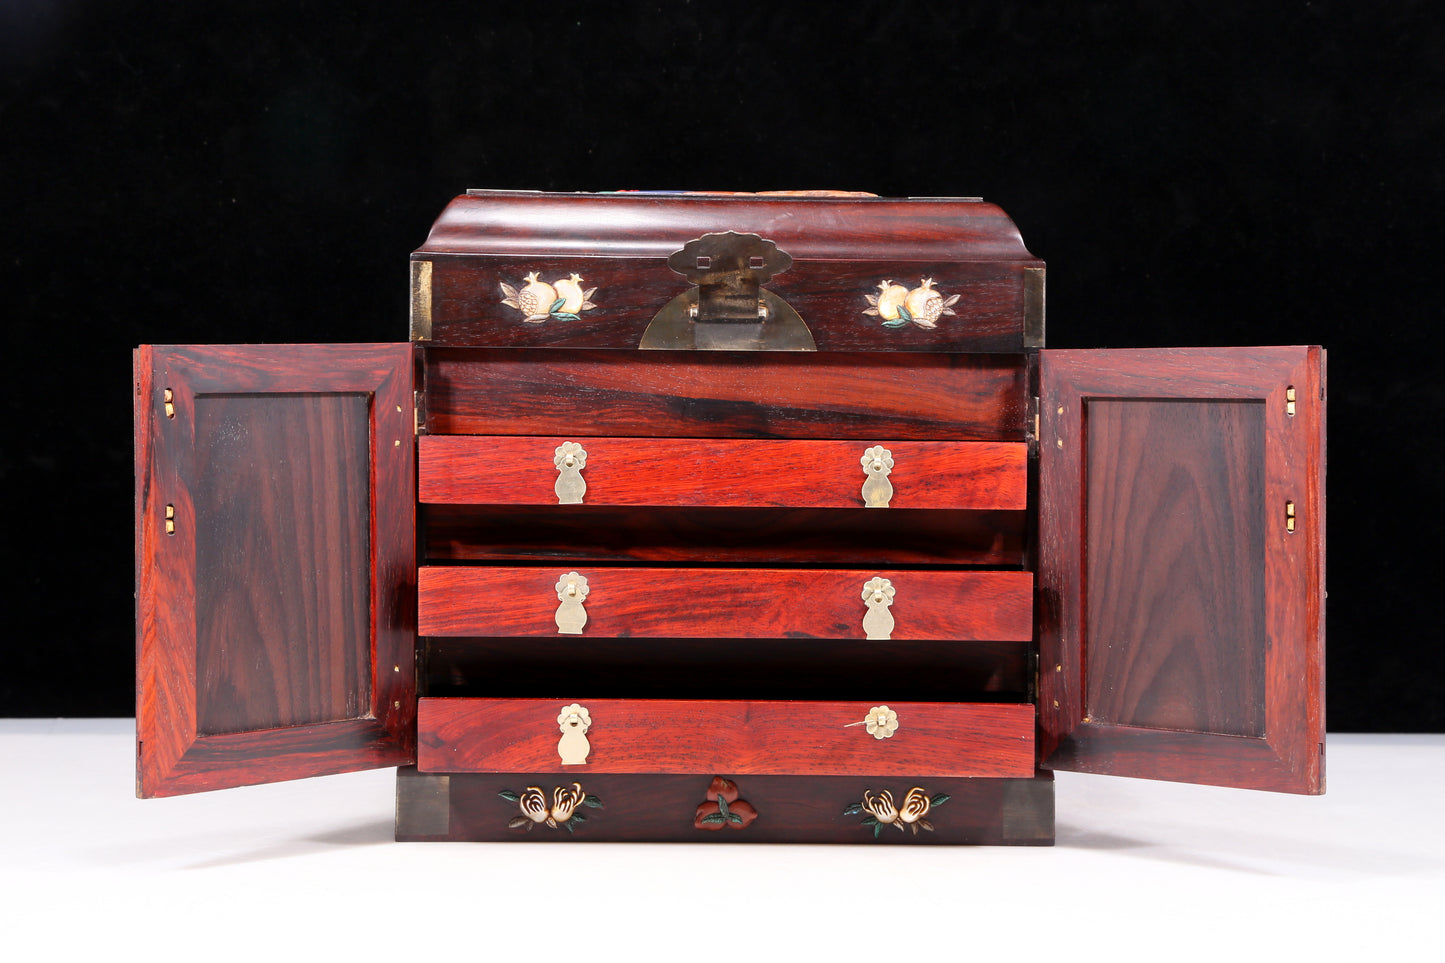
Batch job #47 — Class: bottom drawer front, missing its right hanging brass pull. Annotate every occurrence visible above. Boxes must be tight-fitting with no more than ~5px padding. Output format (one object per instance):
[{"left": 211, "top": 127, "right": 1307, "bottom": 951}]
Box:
[{"left": 416, "top": 698, "right": 1035, "bottom": 778}]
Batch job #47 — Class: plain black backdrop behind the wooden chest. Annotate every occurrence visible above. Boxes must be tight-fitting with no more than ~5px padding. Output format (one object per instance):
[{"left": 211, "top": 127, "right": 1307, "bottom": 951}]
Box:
[{"left": 0, "top": 0, "right": 1445, "bottom": 732}]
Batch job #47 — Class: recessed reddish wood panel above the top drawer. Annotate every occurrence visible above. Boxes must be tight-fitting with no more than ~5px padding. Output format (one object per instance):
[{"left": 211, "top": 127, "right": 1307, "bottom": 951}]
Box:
[{"left": 425, "top": 348, "right": 1027, "bottom": 441}]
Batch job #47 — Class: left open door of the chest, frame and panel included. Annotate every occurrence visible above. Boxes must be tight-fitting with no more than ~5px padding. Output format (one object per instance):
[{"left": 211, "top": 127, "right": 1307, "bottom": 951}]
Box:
[{"left": 134, "top": 344, "right": 416, "bottom": 797}]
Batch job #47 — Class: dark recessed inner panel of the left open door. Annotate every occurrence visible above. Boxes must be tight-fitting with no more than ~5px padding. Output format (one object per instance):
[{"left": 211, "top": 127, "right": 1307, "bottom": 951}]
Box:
[{"left": 191, "top": 393, "right": 371, "bottom": 735}]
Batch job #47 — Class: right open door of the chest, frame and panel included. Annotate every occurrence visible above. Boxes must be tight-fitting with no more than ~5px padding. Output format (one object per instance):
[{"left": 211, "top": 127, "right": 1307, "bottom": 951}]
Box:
[{"left": 1038, "top": 347, "right": 1325, "bottom": 792}]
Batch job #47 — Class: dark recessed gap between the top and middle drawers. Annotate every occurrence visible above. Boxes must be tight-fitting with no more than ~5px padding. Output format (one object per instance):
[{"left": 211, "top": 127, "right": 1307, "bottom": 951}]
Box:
[{"left": 420, "top": 505, "right": 1027, "bottom": 568}]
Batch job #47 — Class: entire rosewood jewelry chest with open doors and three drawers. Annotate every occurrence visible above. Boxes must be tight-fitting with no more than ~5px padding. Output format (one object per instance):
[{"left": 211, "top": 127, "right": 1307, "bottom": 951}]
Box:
[{"left": 134, "top": 191, "right": 1325, "bottom": 844}]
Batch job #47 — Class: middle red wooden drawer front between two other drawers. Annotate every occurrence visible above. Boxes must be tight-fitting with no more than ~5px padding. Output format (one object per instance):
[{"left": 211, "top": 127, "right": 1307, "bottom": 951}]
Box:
[{"left": 416, "top": 565, "right": 1033, "bottom": 642}]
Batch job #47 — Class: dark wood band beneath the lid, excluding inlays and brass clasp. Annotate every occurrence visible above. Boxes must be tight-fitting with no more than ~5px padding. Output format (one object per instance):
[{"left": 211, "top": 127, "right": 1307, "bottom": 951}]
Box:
[{"left": 428, "top": 257, "right": 1040, "bottom": 353}]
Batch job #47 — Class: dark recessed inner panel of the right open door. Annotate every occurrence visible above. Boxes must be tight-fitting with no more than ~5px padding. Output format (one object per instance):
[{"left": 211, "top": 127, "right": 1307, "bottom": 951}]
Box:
[{"left": 1084, "top": 399, "right": 1266, "bottom": 737}]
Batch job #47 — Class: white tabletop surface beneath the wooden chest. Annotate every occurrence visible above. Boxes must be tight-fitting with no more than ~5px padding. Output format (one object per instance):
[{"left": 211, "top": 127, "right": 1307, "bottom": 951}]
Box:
[{"left": 0, "top": 719, "right": 1445, "bottom": 963}]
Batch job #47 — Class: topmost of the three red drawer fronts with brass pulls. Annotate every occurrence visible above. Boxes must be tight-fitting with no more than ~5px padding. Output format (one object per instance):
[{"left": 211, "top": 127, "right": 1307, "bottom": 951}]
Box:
[{"left": 418, "top": 435, "right": 1027, "bottom": 510}]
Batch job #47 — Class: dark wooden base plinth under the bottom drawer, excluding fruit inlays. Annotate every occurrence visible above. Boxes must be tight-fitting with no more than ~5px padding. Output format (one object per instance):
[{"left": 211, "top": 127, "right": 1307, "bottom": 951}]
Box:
[{"left": 396, "top": 766, "right": 1053, "bottom": 846}]
